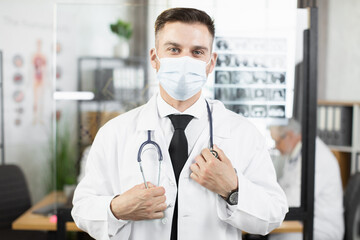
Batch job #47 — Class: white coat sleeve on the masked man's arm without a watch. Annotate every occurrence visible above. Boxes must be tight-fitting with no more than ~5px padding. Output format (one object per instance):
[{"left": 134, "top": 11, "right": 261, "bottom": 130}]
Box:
[{"left": 71, "top": 128, "right": 127, "bottom": 239}]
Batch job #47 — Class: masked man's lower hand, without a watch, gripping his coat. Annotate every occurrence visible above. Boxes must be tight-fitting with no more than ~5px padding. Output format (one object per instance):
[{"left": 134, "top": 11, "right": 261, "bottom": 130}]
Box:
[{"left": 110, "top": 182, "right": 167, "bottom": 220}]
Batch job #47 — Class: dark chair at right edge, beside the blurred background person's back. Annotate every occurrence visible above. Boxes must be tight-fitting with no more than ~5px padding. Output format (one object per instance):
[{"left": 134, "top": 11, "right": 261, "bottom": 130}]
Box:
[{"left": 344, "top": 172, "right": 360, "bottom": 240}]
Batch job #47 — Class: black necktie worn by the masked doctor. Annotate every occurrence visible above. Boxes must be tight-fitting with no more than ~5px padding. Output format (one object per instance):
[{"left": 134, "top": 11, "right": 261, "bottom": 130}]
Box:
[{"left": 169, "top": 114, "right": 193, "bottom": 240}]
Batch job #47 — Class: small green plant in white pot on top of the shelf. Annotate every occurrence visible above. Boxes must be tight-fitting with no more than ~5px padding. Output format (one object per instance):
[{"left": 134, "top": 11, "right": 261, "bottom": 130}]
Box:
[{"left": 110, "top": 19, "right": 133, "bottom": 58}]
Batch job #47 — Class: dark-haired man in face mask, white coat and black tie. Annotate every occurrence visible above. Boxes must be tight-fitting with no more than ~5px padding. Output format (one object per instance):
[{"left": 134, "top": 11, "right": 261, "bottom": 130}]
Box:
[{"left": 72, "top": 8, "right": 288, "bottom": 240}]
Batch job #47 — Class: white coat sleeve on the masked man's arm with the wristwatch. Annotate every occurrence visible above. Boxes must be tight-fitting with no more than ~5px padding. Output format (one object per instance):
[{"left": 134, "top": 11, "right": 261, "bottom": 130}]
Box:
[{"left": 217, "top": 131, "right": 288, "bottom": 235}]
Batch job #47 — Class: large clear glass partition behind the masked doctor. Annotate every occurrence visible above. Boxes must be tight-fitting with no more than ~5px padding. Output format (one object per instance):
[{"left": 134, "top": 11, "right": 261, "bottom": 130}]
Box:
[{"left": 54, "top": 0, "right": 307, "bottom": 238}]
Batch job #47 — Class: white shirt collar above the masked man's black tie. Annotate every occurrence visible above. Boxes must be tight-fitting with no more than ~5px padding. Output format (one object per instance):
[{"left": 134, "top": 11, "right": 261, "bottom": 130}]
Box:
[{"left": 157, "top": 93, "right": 206, "bottom": 119}]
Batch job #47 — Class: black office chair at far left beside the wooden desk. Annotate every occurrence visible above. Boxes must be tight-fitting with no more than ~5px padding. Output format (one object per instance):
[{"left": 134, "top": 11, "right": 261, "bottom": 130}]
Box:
[{"left": 0, "top": 165, "right": 47, "bottom": 240}]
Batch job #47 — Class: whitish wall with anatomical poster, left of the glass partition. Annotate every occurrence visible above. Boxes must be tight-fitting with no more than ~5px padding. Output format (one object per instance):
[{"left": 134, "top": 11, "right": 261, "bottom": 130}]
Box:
[{"left": 0, "top": 0, "right": 53, "bottom": 202}]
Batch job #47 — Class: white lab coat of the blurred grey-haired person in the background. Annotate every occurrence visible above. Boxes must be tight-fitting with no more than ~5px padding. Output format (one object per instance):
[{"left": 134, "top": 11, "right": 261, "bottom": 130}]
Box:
[{"left": 269, "top": 138, "right": 344, "bottom": 240}]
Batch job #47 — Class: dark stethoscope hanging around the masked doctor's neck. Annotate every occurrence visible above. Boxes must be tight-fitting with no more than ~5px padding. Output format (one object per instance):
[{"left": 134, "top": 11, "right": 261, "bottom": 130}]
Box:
[{"left": 137, "top": 100, "right": 219, "bottom": 188}]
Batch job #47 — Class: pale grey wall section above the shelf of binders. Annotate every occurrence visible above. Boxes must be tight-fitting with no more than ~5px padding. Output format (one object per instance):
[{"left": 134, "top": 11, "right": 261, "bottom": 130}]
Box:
[{"left": 319, "top": 0, "right": 360, "bottom": 101}]
